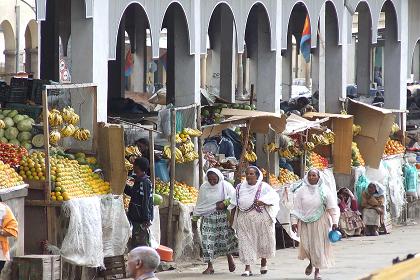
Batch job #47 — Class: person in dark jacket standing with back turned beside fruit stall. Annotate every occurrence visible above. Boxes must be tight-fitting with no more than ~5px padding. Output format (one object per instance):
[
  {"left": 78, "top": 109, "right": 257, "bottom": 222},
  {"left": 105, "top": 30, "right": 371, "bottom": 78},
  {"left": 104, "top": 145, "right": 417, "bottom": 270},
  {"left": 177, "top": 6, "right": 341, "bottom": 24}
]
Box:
[{"left": 124, "top": 157, "right": 153, "bottom": 249}]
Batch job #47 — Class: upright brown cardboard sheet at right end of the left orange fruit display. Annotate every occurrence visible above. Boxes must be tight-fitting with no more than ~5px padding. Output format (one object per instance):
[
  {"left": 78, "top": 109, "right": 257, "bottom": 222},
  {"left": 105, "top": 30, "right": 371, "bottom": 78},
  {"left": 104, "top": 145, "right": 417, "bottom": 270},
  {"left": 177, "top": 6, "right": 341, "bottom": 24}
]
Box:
[{"left": 98, "top": 123, "right": 127, "bottom": 195}]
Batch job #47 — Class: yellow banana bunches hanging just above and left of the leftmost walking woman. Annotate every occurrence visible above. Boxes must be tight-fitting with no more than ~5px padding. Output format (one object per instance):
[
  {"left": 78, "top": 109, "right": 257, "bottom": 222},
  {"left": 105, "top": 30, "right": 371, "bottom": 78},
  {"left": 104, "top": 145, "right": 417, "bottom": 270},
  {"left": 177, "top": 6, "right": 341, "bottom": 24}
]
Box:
[{"left": 163, "top": 128, "right": 201, "bottom": 163}]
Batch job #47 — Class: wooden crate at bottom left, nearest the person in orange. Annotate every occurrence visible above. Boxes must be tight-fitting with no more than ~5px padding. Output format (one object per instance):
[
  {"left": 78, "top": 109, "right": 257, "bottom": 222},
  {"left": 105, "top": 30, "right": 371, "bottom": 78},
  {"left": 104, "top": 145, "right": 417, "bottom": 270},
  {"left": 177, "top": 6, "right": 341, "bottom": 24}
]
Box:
[{"left": 11, "top": 255, "right": 62, "bottom": 280}]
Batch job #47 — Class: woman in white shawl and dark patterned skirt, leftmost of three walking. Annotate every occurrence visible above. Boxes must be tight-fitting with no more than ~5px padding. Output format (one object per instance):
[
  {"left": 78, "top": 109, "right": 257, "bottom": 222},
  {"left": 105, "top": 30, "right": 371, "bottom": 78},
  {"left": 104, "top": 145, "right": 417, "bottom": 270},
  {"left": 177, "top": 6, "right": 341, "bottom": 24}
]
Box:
[{"left": 193, "top": 168, "right": 238, "bottom": 274}]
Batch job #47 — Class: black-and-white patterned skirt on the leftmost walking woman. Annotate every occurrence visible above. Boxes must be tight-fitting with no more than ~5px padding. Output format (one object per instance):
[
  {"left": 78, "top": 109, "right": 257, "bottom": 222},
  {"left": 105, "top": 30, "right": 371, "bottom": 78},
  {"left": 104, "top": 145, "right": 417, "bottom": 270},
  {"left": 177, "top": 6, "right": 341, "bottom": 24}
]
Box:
[{"left": 201, "top": 210, "right": 238, "bottom": 262}]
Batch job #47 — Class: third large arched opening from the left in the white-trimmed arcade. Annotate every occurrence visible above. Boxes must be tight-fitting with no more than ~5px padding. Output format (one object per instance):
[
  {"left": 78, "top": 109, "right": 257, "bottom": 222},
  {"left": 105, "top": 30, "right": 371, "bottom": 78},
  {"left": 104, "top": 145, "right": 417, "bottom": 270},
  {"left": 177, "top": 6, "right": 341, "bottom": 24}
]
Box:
[{"left": 206, "top": 3, "right": 238, "bottom": 102}]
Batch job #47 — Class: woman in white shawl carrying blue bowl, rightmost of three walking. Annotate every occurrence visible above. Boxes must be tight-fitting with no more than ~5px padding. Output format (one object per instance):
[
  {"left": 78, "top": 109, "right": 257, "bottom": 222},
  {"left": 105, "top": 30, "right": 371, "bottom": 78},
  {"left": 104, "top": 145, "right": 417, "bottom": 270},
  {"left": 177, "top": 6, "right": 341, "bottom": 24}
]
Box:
[{"left": 291, "top": 169, "right": 340, "bottom": 280}]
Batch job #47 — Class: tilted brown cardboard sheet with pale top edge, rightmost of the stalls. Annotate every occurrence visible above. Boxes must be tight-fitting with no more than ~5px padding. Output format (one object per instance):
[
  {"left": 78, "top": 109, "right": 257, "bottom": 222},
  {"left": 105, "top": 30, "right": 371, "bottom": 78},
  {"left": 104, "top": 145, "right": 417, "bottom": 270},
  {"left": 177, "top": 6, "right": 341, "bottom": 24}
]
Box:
[{"left": 347, "top": 99, "right": 395, "bottom": 168}]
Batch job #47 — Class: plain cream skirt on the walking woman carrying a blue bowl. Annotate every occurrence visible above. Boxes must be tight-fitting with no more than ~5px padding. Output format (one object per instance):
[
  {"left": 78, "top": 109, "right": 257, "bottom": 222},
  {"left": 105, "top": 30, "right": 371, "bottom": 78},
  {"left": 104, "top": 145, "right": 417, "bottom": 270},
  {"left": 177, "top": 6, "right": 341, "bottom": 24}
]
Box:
[{"left": 298, "top": 213, "right": 334, "bottom": 268}]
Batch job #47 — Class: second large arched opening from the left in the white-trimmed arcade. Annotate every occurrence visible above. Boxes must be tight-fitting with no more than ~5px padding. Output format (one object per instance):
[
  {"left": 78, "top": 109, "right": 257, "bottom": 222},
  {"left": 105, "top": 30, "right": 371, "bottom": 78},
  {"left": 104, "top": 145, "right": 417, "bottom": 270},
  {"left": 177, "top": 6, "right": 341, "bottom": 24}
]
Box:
[{"left": 160, "top": 3, "right": 194, "bottom": 106}]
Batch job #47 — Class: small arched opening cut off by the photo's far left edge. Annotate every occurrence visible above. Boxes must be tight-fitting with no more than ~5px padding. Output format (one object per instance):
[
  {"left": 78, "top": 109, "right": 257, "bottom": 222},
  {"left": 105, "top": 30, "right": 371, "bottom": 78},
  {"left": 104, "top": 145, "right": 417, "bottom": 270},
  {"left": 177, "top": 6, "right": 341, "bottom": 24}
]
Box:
[{"left": 0, "top": 20, "right": 16, "bottom": 81}]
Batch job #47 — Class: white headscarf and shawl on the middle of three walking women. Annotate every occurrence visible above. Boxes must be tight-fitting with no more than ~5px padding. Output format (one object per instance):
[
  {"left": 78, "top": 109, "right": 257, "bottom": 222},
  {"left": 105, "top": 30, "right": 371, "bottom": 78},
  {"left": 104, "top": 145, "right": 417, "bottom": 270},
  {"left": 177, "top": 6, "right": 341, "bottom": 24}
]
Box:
[{"left": 230, "top": 166, "right": 280, "bottom": 222}]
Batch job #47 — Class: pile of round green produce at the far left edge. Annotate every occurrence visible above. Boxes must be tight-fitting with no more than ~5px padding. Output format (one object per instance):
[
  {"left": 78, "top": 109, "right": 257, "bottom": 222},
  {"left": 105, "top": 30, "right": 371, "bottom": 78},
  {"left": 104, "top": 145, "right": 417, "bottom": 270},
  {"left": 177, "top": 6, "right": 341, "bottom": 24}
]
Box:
[{"left": 0, "top": 110, "right": 35, "bottom": 150}]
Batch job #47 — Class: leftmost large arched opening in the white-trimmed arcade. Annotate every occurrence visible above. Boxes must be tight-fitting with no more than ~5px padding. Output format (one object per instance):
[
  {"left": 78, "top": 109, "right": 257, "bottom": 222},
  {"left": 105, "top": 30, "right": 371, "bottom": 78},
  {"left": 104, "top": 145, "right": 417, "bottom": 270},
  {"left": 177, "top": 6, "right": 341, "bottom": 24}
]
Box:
[{"left": 108, "top": 4, "right": 153, "bottom": 115}]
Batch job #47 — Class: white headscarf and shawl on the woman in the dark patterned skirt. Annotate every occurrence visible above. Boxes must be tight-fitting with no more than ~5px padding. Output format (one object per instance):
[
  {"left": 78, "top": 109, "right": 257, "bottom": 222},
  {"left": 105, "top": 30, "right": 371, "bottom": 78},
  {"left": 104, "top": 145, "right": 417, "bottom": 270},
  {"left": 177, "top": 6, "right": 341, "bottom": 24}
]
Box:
[{"left": 194, "top": 168, "right": 235, "bottom": 216}]
